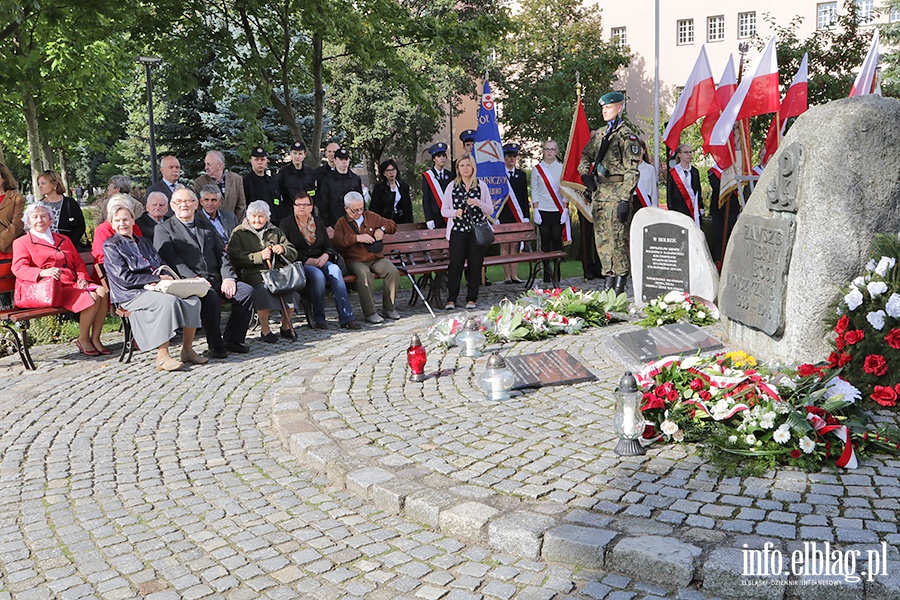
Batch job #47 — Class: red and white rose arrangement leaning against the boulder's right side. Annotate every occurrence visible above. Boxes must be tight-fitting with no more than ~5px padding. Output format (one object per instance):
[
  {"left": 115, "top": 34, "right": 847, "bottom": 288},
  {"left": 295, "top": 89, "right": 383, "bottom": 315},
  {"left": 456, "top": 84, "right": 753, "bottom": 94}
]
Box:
[{"left": 828, "top": 235, "right": 900, "bottom": 406}]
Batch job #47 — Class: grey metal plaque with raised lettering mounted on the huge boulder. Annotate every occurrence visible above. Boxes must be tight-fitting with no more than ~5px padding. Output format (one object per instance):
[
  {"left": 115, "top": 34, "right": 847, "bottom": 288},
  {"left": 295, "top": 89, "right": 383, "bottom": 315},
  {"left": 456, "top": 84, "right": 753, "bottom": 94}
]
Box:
[{"left": 719, "top": 215, "right": 794, "bottom": 336}]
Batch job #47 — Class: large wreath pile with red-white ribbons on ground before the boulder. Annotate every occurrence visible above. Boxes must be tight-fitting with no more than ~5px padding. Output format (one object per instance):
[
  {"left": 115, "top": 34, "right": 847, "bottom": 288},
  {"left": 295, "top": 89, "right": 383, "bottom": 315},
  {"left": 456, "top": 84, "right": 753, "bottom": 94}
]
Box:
[{"left": 635, "top": 352, "right": 900, "bottom": 475}]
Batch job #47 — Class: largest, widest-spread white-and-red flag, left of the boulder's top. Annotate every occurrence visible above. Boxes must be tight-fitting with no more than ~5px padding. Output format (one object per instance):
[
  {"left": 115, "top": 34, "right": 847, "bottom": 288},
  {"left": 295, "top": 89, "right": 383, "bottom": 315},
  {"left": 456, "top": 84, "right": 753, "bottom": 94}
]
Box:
[{"left": 709, "top": 35, "right": 781, "bottom": 146}]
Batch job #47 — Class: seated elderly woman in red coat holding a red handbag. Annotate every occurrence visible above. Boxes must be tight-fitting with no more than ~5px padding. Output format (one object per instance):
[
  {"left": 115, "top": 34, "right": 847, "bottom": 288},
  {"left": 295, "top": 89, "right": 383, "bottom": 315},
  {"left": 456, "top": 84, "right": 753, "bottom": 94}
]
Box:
[{"left": 12, "top": 202, "right": 110, "bottom": 356}]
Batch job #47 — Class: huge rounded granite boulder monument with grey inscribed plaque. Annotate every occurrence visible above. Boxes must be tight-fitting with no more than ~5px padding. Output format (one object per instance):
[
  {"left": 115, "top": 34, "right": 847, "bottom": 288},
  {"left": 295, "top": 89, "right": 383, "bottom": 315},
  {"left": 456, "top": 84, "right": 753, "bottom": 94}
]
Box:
[{"left": 718, "top": 95, "right": 900, "bottom": 364}]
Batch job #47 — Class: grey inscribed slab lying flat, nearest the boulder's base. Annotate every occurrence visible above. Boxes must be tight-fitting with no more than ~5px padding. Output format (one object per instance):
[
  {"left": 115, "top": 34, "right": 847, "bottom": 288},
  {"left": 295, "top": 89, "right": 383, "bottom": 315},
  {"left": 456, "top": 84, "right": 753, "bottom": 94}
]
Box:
[{"left": 613, "top": 323, "right": 723, "bottom": 363}]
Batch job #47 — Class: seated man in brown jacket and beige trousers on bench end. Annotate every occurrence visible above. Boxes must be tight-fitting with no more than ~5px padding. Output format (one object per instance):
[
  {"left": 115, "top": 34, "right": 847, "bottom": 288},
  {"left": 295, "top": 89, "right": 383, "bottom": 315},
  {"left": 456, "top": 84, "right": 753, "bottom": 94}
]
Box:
[{"left": 332, "top": 192, "right": 400, "bottom": 323}]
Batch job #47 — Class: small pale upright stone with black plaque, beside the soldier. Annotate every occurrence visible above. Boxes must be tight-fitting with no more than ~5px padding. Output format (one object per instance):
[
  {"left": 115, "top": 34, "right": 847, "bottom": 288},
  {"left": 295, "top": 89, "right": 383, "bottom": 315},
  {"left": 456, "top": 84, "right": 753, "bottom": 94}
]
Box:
[{"left": 630, "top": 207, "right": 719, "bottom": 307}]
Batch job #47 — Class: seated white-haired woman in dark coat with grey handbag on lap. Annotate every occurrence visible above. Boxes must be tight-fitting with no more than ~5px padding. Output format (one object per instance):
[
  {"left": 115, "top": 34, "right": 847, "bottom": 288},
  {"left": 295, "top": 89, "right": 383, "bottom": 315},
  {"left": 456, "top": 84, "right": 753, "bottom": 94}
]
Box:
[{"left": 228, "top": 200, "right": 298, "bottom": 344}]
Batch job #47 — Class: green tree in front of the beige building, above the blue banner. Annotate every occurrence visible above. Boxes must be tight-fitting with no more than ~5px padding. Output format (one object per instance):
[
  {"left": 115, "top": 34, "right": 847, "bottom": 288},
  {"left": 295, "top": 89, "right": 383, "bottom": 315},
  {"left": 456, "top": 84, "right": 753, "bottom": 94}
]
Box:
[{"left": 497, "top": 0, "right": 630, "bottom": 150}]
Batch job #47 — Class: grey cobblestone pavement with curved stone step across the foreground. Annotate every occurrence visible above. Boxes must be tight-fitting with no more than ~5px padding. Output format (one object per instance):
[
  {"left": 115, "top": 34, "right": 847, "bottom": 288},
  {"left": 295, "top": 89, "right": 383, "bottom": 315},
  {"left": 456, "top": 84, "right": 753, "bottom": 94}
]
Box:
[{"left": 0, "top": 282, "right": 900, "bottom": 600}]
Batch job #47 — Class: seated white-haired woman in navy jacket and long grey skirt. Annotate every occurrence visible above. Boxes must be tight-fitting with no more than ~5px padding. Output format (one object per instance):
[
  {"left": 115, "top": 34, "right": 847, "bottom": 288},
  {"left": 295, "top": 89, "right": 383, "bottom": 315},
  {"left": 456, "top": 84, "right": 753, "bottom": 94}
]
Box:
[{"left": 103, "top": 200, "right": 207, "bottom": 371}]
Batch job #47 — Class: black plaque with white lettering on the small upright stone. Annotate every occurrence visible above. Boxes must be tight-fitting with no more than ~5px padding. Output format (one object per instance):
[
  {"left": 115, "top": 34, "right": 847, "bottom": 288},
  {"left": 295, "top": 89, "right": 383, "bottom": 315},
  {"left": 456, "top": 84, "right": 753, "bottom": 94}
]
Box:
[{"left": 641, "top": 223, "right": 691, "bottom": 303}]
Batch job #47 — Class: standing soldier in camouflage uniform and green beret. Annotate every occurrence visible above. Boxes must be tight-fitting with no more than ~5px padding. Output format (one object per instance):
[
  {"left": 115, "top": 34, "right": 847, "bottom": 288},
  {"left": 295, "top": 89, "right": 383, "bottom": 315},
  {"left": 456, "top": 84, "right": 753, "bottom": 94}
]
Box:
[{"left": 578, "top": 92, "right": 641, "bottom": 294}]
